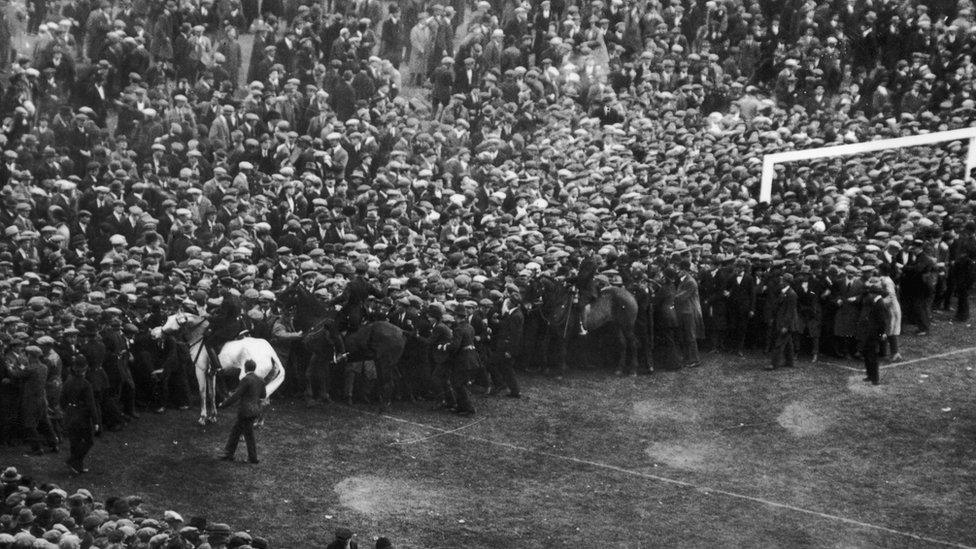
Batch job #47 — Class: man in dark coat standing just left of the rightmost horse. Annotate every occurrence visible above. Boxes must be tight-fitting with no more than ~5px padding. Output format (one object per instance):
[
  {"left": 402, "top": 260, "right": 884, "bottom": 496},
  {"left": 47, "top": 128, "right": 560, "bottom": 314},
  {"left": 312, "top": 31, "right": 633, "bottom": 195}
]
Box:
[{"left": 488, "top": 283, "right": 525, "bottom": 398}]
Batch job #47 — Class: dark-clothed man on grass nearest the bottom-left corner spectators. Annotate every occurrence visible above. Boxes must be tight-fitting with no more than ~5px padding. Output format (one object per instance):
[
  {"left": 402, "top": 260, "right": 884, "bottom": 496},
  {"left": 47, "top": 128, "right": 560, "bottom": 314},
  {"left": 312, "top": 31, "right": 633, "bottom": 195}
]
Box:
[{"left": 61, "top": 355, "right": 101, "bottom": 475}]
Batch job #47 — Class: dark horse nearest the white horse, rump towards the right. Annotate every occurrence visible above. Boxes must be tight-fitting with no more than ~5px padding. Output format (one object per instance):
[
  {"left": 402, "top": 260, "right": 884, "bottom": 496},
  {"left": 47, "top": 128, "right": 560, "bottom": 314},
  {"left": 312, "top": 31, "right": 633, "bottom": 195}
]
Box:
[{"left": 302, "top": 310, "right": 406, "bottom": 409}]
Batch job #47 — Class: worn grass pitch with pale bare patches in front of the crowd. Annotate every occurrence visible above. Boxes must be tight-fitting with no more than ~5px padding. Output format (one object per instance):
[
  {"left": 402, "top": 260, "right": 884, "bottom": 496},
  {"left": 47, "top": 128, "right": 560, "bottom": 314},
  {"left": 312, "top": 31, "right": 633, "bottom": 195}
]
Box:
[{"left": 0, "top": 314, "right": 976, "bottom": 548}]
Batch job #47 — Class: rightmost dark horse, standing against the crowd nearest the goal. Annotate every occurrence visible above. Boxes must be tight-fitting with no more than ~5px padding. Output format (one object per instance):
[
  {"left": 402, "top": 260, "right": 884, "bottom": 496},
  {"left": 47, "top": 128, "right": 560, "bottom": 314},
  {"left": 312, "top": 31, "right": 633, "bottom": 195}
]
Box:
[{"left": 528, "top": 276, "right": 637, "bottom": 373}]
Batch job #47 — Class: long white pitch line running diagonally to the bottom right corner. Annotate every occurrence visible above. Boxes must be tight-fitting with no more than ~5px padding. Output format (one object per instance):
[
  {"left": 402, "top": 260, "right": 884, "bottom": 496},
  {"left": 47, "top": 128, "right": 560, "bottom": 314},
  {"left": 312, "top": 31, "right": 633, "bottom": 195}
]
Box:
[{"left": 361, "top": 412, "right": 976, "bottom": 549}]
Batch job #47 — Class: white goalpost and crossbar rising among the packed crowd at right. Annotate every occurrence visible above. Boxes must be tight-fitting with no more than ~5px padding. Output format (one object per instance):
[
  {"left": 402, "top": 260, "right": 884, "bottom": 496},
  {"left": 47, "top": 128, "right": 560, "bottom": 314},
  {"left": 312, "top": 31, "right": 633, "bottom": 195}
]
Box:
[{"left": 759, "top": 127, "right": 976, "bottom": 202}]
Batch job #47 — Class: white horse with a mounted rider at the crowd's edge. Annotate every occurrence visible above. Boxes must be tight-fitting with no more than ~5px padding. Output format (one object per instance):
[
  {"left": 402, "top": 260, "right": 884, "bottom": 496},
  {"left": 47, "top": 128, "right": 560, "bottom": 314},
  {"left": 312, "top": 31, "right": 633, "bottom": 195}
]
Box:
[{"left": 152, "top": 312, "right": 285, "bottom": 425}]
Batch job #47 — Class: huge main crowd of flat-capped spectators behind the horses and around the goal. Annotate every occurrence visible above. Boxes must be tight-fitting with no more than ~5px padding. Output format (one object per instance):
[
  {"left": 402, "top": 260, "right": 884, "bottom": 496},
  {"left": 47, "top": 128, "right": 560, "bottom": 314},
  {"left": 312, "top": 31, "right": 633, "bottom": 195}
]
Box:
[{"left": 0, "top": 0, "right": 976, "bottom": 484}]
